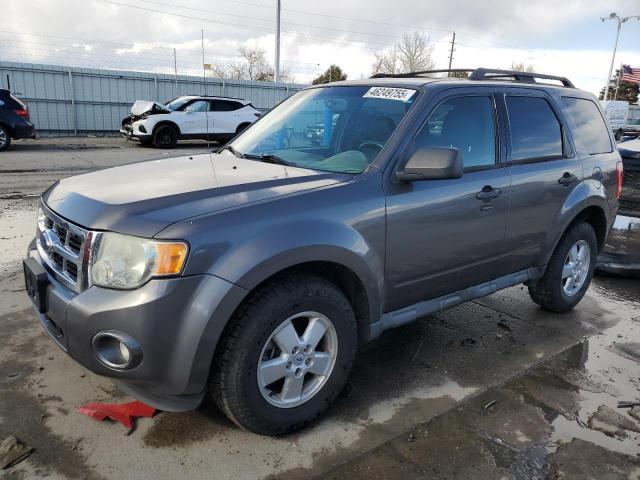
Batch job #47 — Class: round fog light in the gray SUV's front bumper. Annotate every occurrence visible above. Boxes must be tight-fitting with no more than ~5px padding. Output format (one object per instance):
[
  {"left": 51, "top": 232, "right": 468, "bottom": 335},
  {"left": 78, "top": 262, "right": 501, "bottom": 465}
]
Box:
[{"left": 91, "top": 330, "right": 142, "bottom": 370}]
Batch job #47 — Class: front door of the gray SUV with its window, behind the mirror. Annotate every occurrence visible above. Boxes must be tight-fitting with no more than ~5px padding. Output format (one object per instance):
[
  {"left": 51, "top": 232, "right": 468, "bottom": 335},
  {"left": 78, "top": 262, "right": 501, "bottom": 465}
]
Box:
[{"left": 385, "top": 92, "right": 510, "bottom": 311}]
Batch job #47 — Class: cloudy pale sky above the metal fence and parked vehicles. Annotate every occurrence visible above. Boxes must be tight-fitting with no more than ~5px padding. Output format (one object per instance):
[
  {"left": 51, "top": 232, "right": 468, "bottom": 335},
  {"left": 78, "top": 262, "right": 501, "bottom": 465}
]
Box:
[{"left": 0, "top": 0, "right": 640, "bottom": 93}]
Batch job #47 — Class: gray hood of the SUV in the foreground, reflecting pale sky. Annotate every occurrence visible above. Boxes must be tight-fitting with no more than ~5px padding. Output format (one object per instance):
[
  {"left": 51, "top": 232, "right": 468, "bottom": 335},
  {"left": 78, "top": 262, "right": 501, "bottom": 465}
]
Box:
[{"left": 42, "top": 151, "right": 351, "bottom": 237}]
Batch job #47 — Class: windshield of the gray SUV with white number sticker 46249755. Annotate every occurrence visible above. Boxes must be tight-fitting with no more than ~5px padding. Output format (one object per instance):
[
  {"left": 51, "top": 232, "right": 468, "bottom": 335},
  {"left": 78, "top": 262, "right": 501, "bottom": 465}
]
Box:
[{"left": 231, "top": 86, "right": 417, "bottom": 173}]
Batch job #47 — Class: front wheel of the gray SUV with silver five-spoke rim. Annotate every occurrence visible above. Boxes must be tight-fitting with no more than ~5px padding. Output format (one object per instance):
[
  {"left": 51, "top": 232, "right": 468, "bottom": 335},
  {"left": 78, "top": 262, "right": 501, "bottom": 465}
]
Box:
[{"left": 209, "top": 273, "right": 358, "bottom": 435}]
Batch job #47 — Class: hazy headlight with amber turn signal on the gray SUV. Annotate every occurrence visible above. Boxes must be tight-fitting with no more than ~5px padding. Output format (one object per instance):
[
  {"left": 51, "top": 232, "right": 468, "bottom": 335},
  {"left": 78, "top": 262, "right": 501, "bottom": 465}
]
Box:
[{"left": 91, "top": 233, "right": 187, "bottom": 289}]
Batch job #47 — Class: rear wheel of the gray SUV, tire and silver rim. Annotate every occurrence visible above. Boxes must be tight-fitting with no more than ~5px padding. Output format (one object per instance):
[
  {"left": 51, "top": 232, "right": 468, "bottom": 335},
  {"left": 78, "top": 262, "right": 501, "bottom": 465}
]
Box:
[{"left": 529, "top": 222, "right": 598, "bottom": 313}]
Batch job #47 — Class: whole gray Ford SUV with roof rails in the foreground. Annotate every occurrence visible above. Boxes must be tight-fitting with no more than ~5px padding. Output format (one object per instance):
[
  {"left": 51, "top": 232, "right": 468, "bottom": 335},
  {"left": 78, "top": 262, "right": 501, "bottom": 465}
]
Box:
[{"left": 24, "top": 69, "right": 622, "bottom": 435}]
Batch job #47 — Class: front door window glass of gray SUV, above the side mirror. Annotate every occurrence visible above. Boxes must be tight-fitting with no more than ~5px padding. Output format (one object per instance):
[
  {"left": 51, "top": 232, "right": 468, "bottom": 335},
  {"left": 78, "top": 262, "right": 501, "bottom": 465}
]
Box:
[{"left": 415, "top": 96, "right": 496, "bottom": 168}]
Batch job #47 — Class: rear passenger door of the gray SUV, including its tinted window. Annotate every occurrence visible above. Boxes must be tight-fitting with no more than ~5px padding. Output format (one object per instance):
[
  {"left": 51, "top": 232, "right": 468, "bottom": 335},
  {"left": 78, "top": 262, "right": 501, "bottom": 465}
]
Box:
[{"left": 500, "top": 89, "right": 584, "bottom": 272}]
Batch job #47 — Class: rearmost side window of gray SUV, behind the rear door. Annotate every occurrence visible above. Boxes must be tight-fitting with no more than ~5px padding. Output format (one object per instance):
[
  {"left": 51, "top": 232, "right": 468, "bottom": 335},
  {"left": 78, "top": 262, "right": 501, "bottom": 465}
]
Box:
[{"left": 562, "top": 97, "right": 613, "bottom": 155}]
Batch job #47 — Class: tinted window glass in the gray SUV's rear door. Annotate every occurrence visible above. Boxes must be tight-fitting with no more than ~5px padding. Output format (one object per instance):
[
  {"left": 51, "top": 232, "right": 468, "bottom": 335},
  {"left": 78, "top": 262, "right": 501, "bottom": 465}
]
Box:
[{"left": 507, "top": 97, "right": 563, "bottom": 160}]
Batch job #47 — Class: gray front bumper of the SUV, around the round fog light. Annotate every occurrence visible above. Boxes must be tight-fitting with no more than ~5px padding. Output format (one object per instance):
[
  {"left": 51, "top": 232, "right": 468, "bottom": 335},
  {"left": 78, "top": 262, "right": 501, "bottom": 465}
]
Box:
[{"left": 28, "top": 244, "right": 246, "bottom": 411}]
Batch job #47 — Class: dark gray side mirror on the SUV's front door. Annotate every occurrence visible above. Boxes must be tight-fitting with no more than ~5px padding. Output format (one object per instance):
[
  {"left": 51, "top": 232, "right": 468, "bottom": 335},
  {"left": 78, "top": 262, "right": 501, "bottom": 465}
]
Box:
[{"left": 396, "top": 147, "right": 463, "bottom": 182}]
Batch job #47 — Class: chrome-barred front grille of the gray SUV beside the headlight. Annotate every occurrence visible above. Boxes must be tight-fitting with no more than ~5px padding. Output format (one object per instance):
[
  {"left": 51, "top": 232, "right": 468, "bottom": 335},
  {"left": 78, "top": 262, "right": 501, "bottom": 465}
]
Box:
[{"left": 36, "top": 205, "right": 92, "bottom": 292}]
